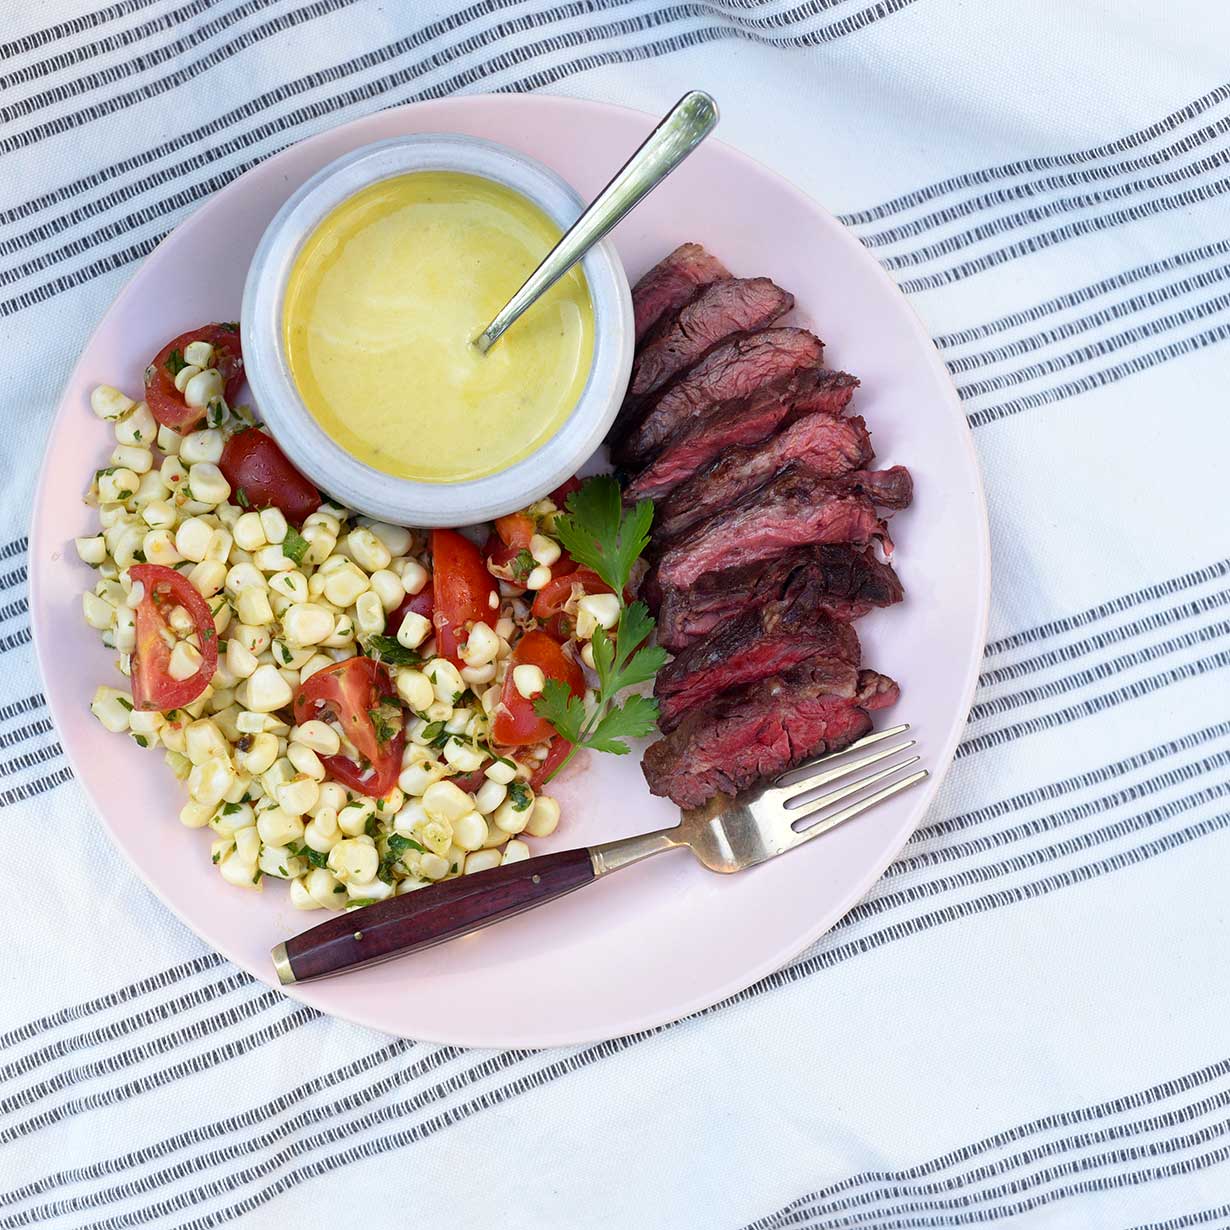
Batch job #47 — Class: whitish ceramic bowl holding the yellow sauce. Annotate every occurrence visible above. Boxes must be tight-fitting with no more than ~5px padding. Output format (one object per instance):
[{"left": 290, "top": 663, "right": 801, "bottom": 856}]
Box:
[{"left": 242, "top": 133, "right": 633, "bottom": 525}]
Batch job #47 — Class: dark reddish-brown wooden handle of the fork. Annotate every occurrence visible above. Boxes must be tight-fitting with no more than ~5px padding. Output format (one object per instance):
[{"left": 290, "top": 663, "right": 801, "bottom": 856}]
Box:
[{"left": 272, "top": 850, "right": 595, "bottom": 983}]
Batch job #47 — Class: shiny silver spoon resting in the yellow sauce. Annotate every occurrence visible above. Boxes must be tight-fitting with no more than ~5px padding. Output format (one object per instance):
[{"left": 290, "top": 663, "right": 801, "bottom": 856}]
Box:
[{"left": 474, "top": 90, "right": 717, "bottom": 354}]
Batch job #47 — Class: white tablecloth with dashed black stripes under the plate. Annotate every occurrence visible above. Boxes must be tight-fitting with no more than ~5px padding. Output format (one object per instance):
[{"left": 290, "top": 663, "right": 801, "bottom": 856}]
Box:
[{"left": 0, "top": 0, "right": 1230, "bottom": 1230}]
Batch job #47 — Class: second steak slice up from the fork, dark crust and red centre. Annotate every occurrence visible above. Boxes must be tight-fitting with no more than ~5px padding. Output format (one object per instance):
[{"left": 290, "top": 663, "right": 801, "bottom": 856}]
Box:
[{"left": 653, "top": 589, "right": 859, "bottom": 733}]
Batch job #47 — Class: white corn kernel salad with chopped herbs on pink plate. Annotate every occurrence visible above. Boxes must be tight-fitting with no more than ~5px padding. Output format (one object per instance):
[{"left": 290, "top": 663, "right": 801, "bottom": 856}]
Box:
[{"left": 76, "top": 369, "right": 585, "bottom": 910}]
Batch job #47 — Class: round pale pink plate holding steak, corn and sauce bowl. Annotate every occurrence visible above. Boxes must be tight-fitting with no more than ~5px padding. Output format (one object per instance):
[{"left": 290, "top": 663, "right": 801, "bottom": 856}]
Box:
[{"left": 30, "top": 96, "right": 989, "bottom": 1047}]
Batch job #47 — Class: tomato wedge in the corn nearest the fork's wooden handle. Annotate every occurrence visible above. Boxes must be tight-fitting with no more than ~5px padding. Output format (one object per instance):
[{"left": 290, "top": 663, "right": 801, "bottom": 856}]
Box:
[{"left": 295, "top": 658, "right": 406, "bottom": 798}]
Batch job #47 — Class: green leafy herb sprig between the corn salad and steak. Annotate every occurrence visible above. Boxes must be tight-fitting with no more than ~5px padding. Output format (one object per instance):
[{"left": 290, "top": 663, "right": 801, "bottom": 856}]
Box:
[{"left": 534, "top": 475, "right": 667, "bottom": 776}]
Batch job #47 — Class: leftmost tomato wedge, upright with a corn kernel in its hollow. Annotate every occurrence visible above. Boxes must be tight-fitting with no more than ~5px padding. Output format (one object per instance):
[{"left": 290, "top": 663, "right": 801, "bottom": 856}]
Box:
[{"left": 128, "top": 563, "right": 218, "bottom": 710}]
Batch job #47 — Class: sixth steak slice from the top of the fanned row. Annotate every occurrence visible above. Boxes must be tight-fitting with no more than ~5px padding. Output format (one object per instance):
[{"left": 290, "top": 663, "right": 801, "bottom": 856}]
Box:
[{"left": 657, "top": 470, "right": 893, "bottom": 590}]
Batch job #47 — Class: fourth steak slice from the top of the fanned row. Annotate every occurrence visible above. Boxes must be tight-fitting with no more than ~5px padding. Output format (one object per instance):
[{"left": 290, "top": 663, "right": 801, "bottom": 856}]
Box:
[{"left": 626, "top": 368, "right": 856, "bottom": 501}]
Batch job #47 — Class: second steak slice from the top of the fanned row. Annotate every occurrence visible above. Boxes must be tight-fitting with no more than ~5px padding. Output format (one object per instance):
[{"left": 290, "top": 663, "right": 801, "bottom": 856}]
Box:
[{"left": 629, "top": 278, "right": 795, "bottom": 397}]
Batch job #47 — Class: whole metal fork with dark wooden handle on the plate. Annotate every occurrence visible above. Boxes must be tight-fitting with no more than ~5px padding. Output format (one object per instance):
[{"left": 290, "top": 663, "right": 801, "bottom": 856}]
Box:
[{"left": 272, "top": 726, "right": 927, "bottom": 983}]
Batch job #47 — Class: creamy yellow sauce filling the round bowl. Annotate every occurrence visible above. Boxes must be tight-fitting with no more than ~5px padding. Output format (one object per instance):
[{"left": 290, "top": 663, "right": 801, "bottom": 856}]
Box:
[{"left": 283, "top": 171, "right": 594, "bottom": 482}]
